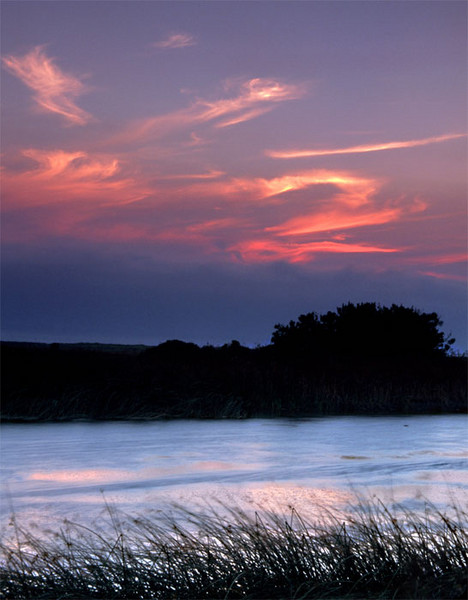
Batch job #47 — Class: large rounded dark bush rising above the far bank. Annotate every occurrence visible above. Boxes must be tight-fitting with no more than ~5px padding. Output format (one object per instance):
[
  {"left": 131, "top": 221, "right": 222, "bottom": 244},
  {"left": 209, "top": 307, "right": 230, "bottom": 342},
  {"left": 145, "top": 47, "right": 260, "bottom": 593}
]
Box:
[{"left": 271, "top": 302, "right": 455, "bottom": 357}]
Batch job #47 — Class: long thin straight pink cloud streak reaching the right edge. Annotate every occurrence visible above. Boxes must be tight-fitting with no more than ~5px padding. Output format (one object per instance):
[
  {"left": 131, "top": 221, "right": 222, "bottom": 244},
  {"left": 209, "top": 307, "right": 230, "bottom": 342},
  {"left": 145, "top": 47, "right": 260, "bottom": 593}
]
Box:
[{"left": 266, "top": 133, "right": 466, "bottom": 158}]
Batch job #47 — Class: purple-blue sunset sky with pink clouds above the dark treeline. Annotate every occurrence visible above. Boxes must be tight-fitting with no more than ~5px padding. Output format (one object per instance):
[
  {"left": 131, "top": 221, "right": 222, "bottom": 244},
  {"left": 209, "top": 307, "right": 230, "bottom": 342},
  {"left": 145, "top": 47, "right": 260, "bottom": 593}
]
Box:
[{"left": 1, "top": 0, "right": 468, "bottom": 352}]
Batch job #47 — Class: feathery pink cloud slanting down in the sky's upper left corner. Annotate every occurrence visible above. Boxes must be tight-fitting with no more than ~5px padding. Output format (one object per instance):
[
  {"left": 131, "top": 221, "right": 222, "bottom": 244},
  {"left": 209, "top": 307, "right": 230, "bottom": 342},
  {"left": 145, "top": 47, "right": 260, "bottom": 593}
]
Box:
[{"left": 2, "top": 46, "right": 91, "bottom": 125}]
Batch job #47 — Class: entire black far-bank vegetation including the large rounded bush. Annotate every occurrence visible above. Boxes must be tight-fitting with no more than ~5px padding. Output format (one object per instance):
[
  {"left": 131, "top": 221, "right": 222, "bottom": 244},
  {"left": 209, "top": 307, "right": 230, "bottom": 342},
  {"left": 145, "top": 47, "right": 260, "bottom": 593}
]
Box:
[{"left": 1, "top": 303, "right": 467, "bottom": 421}]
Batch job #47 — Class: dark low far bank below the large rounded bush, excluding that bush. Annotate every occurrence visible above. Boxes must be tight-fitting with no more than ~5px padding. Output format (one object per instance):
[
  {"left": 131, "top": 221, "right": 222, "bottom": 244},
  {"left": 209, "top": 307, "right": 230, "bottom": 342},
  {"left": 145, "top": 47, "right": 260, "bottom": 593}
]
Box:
[{"left": 1, "top": 341, "right": 467, "bottom": 422}]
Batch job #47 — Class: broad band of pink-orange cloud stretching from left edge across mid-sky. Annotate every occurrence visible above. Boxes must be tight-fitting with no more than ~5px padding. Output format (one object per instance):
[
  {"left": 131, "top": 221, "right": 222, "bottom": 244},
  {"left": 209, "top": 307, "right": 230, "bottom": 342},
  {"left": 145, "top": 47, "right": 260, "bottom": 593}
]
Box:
[{"left": 4, "top": 144, "right": 436, "bottom": 262}]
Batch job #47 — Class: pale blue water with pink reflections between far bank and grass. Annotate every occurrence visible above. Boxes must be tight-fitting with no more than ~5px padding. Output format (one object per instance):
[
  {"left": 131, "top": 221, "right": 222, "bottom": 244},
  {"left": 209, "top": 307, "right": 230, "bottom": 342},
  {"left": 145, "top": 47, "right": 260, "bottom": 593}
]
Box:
[{"left": 1, "top": 415, "right": 468, "bottom": 528}]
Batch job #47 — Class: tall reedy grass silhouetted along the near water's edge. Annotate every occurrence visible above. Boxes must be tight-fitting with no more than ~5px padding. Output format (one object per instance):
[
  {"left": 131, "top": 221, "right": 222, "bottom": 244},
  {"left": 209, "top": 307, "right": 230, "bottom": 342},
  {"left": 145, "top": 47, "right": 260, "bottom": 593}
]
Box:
[{"left": 0, "top": 501, "right": 468, "bottom": 600}]
